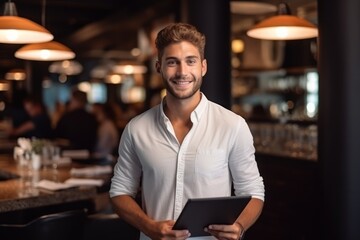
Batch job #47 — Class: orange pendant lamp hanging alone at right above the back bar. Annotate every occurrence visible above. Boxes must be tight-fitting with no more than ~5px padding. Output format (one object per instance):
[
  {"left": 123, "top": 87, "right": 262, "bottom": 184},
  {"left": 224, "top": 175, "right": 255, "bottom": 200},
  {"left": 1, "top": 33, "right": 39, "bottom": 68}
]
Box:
[{"left": 247, "top": 3, "right": 318, "bottom": 40}]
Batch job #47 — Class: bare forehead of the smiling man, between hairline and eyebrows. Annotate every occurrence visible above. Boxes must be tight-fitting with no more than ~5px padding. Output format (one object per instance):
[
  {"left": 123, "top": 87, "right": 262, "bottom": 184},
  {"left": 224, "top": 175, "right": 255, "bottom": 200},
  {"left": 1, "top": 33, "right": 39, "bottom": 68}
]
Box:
[{"left": 163, "top": 41, "right": 200, "bottom": 59}]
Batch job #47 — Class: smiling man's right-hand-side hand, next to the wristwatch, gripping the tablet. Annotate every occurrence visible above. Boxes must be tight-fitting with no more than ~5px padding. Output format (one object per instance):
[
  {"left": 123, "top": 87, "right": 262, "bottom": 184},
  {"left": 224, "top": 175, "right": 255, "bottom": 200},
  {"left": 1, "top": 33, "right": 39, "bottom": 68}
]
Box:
[{"left": 204, "top": 223, "right": 244, "bottom": 240}]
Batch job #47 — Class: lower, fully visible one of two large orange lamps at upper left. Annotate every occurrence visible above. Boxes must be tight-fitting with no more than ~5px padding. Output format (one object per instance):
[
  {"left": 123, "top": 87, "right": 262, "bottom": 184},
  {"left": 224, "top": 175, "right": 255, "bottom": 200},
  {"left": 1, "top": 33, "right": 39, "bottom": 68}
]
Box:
[{"left": 15, "top": 41, "right": 75, "bottom": 61}]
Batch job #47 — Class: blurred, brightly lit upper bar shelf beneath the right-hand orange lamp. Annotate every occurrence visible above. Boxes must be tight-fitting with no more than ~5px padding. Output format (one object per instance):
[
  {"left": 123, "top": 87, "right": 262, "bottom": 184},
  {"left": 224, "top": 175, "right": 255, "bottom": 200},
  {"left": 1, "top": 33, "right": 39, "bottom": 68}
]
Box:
[{"left": 232, "top": 67, "right": 318, "bottom": 122}]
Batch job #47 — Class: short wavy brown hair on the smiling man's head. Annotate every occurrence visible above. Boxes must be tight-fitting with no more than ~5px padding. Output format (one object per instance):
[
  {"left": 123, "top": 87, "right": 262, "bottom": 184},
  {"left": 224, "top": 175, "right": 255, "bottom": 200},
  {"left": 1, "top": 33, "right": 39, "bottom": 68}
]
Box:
[{"left": 155, "top": 23, "right": 205, "bottom": 61}]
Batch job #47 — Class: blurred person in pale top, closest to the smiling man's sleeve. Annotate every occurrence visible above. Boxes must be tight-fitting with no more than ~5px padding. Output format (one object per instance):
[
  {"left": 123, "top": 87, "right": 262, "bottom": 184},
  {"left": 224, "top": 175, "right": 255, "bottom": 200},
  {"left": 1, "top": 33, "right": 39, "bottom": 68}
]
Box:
[{"left": 92, "top": 103, "right": 119, "bottom": 157}]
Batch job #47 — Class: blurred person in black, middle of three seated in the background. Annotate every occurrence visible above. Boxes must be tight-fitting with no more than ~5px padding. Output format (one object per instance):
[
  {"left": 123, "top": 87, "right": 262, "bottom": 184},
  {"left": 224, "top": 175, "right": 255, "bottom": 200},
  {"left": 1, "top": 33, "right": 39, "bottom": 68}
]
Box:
[{"left": 55, "top": 89, "right": 98, "bottom": 153}]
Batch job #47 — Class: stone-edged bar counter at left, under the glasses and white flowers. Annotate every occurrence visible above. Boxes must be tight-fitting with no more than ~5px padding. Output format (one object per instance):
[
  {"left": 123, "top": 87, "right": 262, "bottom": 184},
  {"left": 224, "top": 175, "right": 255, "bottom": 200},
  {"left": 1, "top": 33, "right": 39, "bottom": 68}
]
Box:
[{"left": 0, "top": 154, "right": 111, "bottom": 219}]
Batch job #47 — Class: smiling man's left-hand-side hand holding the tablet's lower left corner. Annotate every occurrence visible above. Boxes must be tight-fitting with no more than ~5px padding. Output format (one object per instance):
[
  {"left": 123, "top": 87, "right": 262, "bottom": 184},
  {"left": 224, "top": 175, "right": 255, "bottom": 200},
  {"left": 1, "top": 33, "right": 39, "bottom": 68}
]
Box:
[{"left": 145, "top": 220, "right": 190, "bottom": 240}]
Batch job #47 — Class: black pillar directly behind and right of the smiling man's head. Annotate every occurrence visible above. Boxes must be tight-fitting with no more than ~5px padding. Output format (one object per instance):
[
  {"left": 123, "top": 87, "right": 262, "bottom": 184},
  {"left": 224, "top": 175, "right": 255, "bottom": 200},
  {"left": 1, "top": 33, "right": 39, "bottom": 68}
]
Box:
[{"left": 181, "top": 0, "right": 231, "bottom": 109}]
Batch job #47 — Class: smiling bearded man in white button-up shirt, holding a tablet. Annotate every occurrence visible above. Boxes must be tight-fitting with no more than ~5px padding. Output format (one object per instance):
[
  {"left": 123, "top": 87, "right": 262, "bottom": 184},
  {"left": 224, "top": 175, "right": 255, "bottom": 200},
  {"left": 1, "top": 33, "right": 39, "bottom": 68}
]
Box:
[{"left": 110, "top": 23, "right": 264, "bottom": 239}]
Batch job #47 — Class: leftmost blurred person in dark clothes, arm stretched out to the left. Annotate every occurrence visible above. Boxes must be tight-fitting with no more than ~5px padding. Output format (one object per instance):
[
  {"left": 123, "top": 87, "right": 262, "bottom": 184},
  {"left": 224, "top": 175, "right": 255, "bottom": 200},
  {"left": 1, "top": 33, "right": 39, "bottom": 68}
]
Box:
[{"left": 8, "top": 96, "right": 53, "bottom": 139}]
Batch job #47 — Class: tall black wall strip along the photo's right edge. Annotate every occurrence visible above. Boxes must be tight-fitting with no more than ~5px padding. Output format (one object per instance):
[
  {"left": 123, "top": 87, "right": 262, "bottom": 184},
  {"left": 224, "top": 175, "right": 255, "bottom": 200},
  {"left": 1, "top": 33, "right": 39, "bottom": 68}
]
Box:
[{"left": 318, "top": 0, "right": 360, "bottom": 240}]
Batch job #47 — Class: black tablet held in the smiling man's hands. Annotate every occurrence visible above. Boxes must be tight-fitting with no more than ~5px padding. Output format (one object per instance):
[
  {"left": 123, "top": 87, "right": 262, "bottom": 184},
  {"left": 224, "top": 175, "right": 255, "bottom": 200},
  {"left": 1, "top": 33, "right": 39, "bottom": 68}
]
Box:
[{"left": 173, "top": 196, "right": 251, "bottom": 237}]
